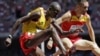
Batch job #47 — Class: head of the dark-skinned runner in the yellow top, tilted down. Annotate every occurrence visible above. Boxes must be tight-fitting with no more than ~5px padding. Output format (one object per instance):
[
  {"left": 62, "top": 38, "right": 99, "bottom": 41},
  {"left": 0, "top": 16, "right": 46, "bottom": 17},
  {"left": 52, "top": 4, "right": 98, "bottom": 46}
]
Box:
[{"left": 46, "top": 2, "right": 61, "bottom": 18}]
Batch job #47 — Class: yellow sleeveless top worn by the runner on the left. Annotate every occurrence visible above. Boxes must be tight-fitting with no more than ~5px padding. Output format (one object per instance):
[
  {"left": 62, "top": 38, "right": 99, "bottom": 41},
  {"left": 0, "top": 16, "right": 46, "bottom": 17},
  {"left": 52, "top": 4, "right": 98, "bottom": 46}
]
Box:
[{"left": 22, "top": 7, "right": 50, "bottom": 33}]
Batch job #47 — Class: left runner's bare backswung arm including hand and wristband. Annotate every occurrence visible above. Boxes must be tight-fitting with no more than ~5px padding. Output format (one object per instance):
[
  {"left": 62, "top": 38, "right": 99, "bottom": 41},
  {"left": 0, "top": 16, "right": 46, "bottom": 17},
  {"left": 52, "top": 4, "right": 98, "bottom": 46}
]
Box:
[{"left": 4, "top": 9, "right": 40, "bottom": 47}]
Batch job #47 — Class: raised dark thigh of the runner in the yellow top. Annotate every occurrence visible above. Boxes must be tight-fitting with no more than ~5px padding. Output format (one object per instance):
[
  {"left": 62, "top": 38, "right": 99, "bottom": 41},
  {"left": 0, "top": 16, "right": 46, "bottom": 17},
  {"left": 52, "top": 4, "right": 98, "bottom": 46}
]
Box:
[{"left": 25, "top": 29, "right": 51, "bottom": 48}]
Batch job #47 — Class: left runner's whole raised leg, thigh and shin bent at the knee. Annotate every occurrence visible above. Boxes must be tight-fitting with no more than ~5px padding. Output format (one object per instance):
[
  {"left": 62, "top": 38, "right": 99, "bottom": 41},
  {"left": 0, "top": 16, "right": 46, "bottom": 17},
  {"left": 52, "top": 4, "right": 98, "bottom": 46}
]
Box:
[{"left": 25, "top": 24, "right": 66, "bottom": 54}]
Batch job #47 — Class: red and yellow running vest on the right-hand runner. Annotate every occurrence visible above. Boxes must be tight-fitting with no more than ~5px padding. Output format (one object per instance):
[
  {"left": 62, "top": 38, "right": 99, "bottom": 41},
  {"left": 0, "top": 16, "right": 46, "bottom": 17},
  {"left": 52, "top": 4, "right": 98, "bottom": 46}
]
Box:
[{"left": 61, "top": 11, "right": 88, "bottom": 31}]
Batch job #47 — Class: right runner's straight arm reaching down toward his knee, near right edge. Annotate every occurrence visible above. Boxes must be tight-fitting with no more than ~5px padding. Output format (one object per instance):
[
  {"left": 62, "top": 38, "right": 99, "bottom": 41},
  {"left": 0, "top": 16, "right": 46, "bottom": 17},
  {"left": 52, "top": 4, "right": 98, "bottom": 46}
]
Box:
[{"left": 86, "top": 15, "right": 95, "bottom": 42}]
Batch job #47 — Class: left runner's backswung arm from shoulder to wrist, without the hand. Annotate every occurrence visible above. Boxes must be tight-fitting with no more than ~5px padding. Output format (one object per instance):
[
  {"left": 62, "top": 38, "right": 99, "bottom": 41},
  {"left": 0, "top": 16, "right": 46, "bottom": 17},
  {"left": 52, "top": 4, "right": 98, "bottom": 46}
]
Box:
[{"left": 10, "top": 7, "right": 43, "bottom": 35}]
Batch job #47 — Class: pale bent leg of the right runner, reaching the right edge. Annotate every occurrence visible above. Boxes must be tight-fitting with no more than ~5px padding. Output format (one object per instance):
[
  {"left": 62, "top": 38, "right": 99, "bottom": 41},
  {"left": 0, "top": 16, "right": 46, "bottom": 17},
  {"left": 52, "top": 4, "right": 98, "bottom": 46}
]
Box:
[{"left": 74, "top": 39, "right": 100, "bottom": 56}]
